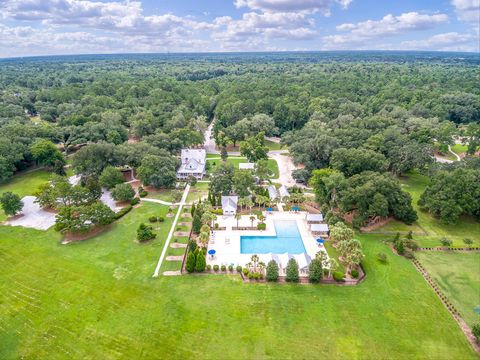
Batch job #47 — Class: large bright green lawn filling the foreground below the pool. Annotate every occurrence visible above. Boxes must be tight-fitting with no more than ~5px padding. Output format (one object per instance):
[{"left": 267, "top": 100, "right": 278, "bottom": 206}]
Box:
[{"left": 0, "top": 217, "right": 476, "bottom": 359}]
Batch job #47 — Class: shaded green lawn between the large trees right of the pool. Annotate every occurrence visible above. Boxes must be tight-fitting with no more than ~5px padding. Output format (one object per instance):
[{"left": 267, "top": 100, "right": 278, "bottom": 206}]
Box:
[{"left": 378, "top": 172, "right": 480, "bottom": 247}]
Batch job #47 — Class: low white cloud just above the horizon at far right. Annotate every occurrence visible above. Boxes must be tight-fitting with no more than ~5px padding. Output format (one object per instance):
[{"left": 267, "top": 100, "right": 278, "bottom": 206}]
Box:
[{"left": 401, "top": 32, "right": 479, "bottom": 51}]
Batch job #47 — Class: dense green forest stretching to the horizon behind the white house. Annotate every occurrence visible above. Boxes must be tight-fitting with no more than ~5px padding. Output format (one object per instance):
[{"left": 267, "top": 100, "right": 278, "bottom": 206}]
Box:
[{"left": 0, "top": 52, "right": 480, "bottom": 224}]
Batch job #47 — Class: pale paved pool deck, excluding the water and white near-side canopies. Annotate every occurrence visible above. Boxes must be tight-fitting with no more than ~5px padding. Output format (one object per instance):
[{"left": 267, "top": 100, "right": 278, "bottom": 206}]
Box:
[{"left": 207, "top": 211, "right": 326, "bottom": 268}]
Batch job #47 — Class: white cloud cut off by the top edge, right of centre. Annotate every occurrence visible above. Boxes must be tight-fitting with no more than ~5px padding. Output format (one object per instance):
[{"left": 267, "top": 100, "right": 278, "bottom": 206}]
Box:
[{"left": 235, "top": 0, "right": 352, "bottom": 15}]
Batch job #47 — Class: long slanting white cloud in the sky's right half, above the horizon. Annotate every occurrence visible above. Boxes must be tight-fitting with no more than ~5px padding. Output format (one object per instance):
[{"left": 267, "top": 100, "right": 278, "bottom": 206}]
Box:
[{"left": 323, "top": 12, "right": 448, "bottom": 49}]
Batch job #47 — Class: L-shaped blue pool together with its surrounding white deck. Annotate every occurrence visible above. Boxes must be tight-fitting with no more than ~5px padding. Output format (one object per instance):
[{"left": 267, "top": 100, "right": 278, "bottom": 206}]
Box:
[{"left": 207, "top": 212, "right": 326, "bottom": 275}]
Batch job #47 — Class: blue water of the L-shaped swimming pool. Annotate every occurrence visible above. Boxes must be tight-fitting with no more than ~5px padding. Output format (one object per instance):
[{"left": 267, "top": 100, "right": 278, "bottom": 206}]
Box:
[{"left": 240, "top": 221, "right": 305, "bottom": 254}]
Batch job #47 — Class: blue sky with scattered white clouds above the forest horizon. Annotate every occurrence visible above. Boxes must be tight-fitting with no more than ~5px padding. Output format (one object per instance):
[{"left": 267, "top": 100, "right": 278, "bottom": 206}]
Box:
[{"left": 0, "top": 0, "right": 480, "bottom": 57}]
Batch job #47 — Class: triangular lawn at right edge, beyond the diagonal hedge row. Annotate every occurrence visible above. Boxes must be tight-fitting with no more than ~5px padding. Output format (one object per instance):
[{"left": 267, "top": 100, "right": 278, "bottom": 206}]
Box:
[{"left": 415, "top": 251, "right": 480, "bottom": 326}]
